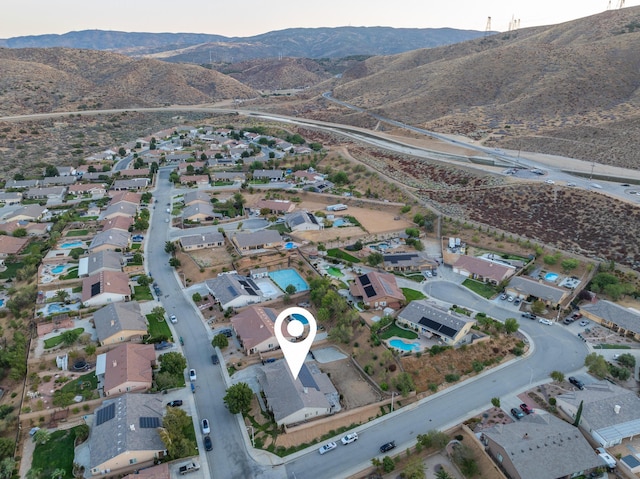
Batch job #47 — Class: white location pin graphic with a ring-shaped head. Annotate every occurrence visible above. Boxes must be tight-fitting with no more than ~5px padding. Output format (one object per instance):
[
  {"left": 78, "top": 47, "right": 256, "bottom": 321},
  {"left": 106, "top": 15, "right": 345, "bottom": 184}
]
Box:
[{"left": 273, "top": 306, "right": 318, "bottom": 379}]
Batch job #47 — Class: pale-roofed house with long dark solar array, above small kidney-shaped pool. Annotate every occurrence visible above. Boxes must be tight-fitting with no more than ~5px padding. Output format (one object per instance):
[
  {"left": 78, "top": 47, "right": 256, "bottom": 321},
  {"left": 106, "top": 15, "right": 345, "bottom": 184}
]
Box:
[{"left": 396, "top": 300, "right": 475, "bottom": 346}]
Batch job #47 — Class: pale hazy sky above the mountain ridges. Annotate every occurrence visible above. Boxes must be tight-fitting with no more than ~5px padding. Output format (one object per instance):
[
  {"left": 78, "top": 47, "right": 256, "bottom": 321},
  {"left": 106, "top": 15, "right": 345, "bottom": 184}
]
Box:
[{"left": 0, "top": 0, "right": 640, "bottom": 38}]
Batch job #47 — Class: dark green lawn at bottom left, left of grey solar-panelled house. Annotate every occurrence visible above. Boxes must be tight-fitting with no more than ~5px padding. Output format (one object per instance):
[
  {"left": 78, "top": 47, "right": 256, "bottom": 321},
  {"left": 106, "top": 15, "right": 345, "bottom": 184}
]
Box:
[{"left": 28, "top": 426, "right": 82, "bottom": 479}]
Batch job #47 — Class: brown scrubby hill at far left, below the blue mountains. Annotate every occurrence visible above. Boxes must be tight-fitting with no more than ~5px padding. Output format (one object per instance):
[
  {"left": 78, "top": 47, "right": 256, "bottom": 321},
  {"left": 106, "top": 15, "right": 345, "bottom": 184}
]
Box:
[{"left": 0, "top": 48, "right": 258, "bottom": 116}]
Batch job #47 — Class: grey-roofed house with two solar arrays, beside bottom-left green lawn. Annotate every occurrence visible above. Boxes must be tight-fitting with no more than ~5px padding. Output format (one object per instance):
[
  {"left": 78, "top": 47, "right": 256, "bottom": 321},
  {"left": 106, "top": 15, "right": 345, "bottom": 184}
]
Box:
[{"left": 87, "top": 394, "right": 165, "bottom": 476}]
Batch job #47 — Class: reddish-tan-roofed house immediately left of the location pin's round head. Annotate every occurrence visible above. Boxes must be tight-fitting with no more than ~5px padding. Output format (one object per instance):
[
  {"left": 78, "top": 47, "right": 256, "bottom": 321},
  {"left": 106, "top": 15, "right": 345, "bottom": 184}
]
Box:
[{"left": 231, "top": 306, "right": 282, "bottom": 356}]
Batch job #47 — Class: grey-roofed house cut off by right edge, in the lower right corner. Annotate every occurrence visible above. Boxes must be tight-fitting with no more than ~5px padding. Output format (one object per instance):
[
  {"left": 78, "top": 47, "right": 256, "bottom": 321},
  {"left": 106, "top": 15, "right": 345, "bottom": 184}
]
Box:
[{"left": 556, "top": 381, "right": 640, "bottom": 447}]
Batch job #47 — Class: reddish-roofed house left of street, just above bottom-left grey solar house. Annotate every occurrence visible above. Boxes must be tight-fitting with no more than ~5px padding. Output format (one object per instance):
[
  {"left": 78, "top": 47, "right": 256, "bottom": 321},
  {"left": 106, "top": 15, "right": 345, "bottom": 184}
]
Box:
[{"left": 96, "top": 343, "right": 156, "bottom": 397}]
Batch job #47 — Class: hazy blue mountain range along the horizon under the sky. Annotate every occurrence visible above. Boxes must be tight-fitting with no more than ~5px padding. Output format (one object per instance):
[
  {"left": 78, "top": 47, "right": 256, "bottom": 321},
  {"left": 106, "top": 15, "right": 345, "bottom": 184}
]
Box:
[{"left": 0, "top": 27, "right": 485, "bottom": 64}]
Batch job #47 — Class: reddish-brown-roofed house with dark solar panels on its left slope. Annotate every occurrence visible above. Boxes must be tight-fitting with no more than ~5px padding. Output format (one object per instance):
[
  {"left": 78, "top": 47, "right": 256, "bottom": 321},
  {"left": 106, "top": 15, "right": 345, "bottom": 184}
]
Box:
[{"left": 350, "top": 271, "right": 405, "bottom": 309}]
